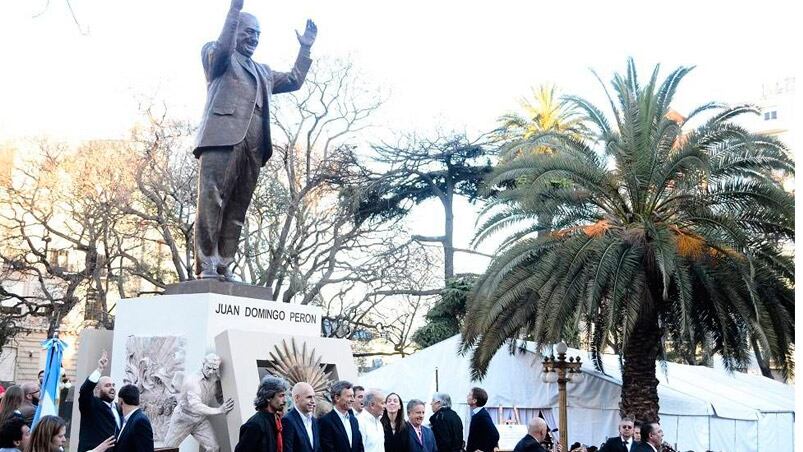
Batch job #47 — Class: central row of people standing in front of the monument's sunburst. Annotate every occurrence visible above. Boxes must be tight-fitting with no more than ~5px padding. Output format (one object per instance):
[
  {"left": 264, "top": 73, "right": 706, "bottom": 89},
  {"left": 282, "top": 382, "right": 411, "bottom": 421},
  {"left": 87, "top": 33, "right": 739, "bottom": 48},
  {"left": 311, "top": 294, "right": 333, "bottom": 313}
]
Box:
[{"left": 235, "top": 376, "right": 499, "bottom": 452}]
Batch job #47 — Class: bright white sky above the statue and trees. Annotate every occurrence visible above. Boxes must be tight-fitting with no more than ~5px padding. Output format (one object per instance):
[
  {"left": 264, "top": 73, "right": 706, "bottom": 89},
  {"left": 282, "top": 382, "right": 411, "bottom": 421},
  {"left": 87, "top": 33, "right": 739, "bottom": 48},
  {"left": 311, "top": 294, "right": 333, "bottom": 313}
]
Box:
[{"left": 0, "top": 0, "right": 801, "bottom": 272}]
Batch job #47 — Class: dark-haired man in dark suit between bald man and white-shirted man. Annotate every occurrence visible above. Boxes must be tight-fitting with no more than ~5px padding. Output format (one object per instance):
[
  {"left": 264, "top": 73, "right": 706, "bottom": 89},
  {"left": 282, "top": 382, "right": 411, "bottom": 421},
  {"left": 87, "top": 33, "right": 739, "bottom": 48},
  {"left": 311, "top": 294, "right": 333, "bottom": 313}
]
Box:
[{"left": 320, "top": 380, "right": 365, "bottom": 452}]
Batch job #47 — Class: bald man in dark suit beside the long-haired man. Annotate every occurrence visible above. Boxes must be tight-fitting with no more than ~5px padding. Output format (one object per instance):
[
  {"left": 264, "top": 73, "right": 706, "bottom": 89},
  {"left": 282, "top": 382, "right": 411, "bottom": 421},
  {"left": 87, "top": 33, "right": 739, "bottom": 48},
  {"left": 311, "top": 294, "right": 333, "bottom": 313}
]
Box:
[{"left": 282, "top": 382, "right": 321, "bottom": 452}]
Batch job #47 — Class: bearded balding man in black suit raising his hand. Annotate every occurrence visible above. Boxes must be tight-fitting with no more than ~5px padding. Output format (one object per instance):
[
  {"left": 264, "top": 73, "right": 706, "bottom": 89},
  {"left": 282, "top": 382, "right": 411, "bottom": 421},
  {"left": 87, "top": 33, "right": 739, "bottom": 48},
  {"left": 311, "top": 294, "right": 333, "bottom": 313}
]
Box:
[{"left": 78, "top": 350, "right": 123, "bottom": 452}]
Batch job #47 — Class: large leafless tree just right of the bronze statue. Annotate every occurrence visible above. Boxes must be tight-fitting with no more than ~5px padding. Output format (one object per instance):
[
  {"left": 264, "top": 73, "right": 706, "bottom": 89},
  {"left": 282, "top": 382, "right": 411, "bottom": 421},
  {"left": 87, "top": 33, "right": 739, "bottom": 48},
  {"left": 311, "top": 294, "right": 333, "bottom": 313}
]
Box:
[{"left": 232, "top": 57, "right": 438, "bottom": 353}]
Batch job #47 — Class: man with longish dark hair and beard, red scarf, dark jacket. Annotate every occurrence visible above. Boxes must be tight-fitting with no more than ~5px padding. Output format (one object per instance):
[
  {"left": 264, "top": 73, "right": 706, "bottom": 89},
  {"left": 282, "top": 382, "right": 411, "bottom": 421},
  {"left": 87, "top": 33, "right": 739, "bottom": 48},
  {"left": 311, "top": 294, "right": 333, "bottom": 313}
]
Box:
[{"left": 234, "top": 375, "right": 287, "bottom": 452}]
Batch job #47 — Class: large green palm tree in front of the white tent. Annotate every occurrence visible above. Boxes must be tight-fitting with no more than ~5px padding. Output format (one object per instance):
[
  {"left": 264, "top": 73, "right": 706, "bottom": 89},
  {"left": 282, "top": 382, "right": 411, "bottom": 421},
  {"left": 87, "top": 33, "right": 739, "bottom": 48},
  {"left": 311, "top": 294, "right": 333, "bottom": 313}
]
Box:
[{"left": 462, "top": 60, "right": 794, "bottom": 420}]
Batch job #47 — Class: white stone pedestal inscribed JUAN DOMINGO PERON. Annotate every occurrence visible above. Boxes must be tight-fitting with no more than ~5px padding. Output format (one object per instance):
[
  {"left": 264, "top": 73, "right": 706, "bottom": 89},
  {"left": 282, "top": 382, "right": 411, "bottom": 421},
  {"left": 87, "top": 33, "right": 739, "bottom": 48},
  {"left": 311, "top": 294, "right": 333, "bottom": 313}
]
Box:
[{"left": 104, "top": 281, "right": 326, "bottom": 452}]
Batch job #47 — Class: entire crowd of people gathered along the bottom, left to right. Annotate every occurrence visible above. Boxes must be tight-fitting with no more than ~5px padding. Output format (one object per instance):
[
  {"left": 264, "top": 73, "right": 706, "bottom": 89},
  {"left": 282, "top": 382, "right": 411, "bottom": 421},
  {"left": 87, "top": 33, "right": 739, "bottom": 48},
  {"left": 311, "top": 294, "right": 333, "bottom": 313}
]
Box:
[{"left": 0, "top": 353, "right": 667, "bottom": 452}]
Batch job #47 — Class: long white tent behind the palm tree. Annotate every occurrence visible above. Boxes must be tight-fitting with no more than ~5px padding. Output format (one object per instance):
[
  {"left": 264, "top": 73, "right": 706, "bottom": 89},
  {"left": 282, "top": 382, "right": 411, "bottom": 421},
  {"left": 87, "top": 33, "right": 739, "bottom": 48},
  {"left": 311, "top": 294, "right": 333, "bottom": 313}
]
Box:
[{"left": 360, "top": 336, "right": 795, "bottom": 452}]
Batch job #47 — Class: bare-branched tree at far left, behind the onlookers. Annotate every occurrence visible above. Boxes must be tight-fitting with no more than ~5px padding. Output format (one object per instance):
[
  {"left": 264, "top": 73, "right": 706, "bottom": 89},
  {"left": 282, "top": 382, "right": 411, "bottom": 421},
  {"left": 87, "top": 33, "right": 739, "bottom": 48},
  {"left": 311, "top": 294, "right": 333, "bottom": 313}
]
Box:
[{"left": 0, "top": 140, "right": 132, "bottom": 334}]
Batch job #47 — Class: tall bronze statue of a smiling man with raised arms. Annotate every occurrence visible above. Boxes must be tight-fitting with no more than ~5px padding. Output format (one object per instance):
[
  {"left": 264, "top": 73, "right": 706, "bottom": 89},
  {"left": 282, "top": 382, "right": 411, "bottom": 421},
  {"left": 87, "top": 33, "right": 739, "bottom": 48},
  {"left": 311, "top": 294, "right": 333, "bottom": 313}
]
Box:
[{"left": 193, "top": 0, "right": 318, "bottom": 280}]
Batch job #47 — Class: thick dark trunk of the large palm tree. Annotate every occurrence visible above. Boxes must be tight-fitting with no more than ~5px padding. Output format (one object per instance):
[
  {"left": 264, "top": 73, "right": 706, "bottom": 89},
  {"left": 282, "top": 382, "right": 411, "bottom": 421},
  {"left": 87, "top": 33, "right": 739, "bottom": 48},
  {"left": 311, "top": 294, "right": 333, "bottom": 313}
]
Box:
[{"left": 619, "top": 303, "right": 661, "bottom": 422}]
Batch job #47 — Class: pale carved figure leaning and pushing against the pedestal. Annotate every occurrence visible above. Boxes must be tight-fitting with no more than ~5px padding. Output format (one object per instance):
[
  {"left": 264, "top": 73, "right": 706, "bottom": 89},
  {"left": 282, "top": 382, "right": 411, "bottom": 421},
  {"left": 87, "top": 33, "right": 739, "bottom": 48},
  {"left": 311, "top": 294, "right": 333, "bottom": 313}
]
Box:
[{"left": 165, "top": 353, "right": 234, "bottom": 452}]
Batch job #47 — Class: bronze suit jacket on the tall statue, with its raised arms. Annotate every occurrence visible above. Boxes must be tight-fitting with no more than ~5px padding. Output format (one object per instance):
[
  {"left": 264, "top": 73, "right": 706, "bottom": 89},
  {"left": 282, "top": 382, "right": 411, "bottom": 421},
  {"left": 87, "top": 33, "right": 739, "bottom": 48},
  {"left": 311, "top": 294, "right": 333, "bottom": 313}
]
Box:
[{"left": 193, "top": 10, "right": 312, "bottom": 165}]
